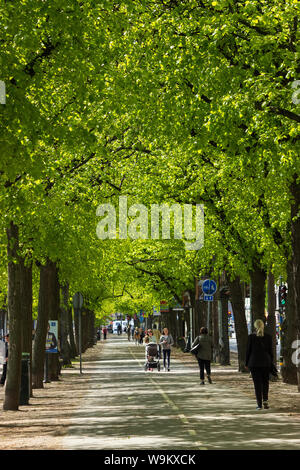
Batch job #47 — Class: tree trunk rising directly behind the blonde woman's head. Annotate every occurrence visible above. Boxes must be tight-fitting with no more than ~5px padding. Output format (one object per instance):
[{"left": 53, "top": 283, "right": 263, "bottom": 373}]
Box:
[{"left": 250, "top": 264, "right": 267, "bottom": 329}]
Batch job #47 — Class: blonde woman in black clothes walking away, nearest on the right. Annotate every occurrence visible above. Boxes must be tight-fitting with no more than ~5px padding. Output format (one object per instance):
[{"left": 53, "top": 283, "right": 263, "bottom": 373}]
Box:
[{"left": 246, "top": 320, "right": 273, "bottom": 410}]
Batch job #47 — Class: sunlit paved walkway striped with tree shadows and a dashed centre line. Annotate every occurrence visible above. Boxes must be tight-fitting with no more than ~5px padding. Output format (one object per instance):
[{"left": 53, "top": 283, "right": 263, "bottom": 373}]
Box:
[{"left": 63, "top": 335, "right": 300, "bottom": 450}]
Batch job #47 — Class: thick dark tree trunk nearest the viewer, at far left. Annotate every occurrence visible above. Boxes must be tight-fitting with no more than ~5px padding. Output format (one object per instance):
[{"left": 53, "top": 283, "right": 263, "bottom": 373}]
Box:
[{"left": 3, "top": 222, "right": 22, "bottom": 411}]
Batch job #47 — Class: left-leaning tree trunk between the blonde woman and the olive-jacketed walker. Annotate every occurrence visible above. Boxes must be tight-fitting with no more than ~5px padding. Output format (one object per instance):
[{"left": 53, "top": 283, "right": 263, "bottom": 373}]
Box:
[{"left": 227, "top": 276, "right": 248, "bottom": 372}]
